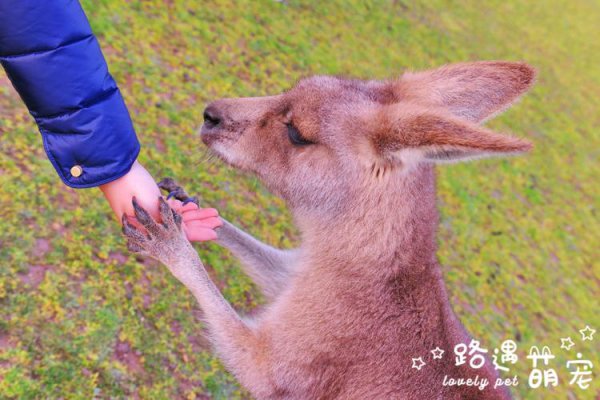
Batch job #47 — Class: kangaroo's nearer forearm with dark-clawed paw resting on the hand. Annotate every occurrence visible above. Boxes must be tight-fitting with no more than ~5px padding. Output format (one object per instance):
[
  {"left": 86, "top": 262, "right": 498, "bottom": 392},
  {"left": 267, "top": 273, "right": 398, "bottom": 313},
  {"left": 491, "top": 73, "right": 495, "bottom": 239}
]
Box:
[{"left": 122, "top": 197, "right": 268, "bottom": 397}]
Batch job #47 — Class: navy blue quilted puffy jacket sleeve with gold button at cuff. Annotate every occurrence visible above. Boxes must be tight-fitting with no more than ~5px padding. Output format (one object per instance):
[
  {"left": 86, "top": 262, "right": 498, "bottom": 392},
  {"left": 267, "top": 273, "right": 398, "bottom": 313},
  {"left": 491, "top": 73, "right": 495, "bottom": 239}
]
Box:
[{"left": 0, "top": 0, "right": 140, "bottom": 188}]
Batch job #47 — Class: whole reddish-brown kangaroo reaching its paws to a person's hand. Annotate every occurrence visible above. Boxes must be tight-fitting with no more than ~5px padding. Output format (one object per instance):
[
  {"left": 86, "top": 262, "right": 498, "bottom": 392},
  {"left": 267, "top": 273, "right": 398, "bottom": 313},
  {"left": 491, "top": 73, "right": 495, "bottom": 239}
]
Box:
[{"left": 123, "top": 61, "right": 535, "bottom": 400}]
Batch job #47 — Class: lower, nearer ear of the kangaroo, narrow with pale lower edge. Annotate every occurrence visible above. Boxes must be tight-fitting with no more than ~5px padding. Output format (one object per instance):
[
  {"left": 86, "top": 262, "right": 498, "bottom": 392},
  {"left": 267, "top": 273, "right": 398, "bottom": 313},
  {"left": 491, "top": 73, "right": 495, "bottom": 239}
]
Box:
[{"left": 371, "top": 106, "right": 532, "bottom": 164}]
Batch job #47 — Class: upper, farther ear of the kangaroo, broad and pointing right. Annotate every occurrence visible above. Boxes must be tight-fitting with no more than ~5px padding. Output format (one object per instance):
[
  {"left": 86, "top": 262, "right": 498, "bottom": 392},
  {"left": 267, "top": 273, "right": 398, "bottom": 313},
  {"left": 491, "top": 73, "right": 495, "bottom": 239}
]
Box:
[{"left": 392, "top": 61, "right": 536, "bottom": 122}]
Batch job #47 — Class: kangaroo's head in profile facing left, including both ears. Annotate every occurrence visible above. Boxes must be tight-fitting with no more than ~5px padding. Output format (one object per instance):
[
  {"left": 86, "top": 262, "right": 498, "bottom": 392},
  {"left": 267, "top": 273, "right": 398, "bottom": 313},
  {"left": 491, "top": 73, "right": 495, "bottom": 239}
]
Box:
[{"left": 201, "top": 62, "right": 535, "bottom": 217}]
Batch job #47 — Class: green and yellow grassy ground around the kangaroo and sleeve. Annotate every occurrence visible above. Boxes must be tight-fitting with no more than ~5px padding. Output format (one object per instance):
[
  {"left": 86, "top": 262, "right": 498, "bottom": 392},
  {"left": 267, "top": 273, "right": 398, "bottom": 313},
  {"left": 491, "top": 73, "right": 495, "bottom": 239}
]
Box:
[{"left": 0, "top": 0, "right": 600, "bottom": 399}]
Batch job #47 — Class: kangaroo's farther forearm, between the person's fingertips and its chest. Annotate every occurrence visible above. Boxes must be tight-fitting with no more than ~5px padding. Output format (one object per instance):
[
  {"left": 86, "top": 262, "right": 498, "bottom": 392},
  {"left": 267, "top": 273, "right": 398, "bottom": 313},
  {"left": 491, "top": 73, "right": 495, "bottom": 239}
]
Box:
[{"left": 217, "top": 219, "right": 296, "bottom": 295}]
